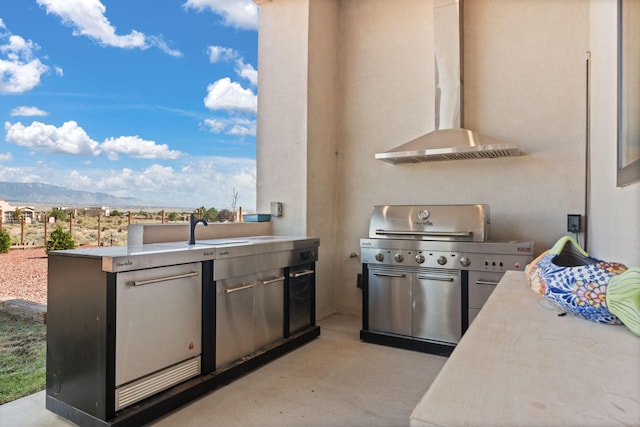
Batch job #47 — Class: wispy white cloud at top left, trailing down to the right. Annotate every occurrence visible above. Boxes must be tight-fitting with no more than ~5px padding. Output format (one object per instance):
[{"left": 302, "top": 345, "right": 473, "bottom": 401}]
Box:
[{"left": 36, "top": 0, "right": 182, "bottom": 56}]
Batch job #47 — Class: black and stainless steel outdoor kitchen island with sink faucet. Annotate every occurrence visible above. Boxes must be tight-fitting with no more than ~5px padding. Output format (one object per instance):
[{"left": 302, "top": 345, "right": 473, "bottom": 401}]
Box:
[{"left": 46, "top": 236, "right": 320, "bottom": 426}]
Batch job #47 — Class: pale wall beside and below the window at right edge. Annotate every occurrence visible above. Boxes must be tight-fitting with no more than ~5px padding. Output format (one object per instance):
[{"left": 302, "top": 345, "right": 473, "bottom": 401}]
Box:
[{"left": 589, "top": 0, "right": 640, "bottom": 267}]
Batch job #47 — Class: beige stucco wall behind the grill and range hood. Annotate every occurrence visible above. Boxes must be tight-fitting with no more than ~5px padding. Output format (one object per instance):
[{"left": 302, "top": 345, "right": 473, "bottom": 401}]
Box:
[{"left": 336, "top": 0, "right": 588, "bottom": 312}]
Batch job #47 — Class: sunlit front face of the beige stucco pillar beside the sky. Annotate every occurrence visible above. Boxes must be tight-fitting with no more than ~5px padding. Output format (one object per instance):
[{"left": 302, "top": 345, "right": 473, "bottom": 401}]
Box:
[{"left": 256, "top": 0, "right": 309, "bottom": 236}]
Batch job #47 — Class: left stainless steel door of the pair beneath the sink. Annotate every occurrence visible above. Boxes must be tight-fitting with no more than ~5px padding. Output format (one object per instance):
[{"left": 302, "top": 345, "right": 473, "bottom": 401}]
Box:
[{"left": 214, "top": 274, "right": 255, "bottom": 368}]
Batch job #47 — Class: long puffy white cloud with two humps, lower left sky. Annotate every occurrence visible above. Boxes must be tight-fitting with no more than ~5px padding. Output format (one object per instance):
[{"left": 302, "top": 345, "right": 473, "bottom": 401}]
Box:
[{"left": 4, "top": 121, "right": 182, "bottom": 160}]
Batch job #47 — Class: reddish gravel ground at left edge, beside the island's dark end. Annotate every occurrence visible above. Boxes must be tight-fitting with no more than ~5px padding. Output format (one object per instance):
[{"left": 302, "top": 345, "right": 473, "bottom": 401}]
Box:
[{"left": 0, "top": 248, "right": 47, "bottom": 304}]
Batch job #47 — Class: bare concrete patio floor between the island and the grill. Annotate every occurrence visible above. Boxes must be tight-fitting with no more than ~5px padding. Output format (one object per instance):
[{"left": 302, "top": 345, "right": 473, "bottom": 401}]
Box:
[{"left": 0, "top": 314, "right": 446, "bottom": 427}]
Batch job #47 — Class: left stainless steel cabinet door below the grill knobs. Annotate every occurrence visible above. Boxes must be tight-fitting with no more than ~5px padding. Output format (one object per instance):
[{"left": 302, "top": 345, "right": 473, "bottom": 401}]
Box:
[{"left": 368, "top": 268, "right": 412, "bottom": 335}]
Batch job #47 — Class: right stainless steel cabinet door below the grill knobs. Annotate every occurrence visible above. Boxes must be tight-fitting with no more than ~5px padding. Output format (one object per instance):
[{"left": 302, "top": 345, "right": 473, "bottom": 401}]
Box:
[{"left": 412, "top": 270, "right": 462, "bottom": 343}]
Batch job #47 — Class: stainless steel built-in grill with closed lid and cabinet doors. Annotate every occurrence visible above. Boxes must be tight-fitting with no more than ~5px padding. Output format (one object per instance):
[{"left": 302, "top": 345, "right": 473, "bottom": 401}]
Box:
[{"left": 360, "top": 204, "right": 534, "bottom": 356}]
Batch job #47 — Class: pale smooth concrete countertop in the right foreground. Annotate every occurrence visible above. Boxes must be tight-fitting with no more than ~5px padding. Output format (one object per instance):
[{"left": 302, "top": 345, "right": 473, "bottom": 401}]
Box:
[{"left": 411, "top": 271, "right": 640, "bottom": 427}]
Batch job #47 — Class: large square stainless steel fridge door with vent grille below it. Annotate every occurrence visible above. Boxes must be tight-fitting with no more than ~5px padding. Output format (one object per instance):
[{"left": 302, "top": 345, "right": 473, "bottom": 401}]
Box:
[{"left": 115, "top": 263, "right": 202, "bottom": 386}]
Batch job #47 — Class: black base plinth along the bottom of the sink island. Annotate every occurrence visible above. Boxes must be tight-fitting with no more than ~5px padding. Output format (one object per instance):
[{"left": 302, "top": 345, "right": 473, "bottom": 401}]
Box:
[{"left": 46, "top": 326, "right": 320, "bottom": 427}]
